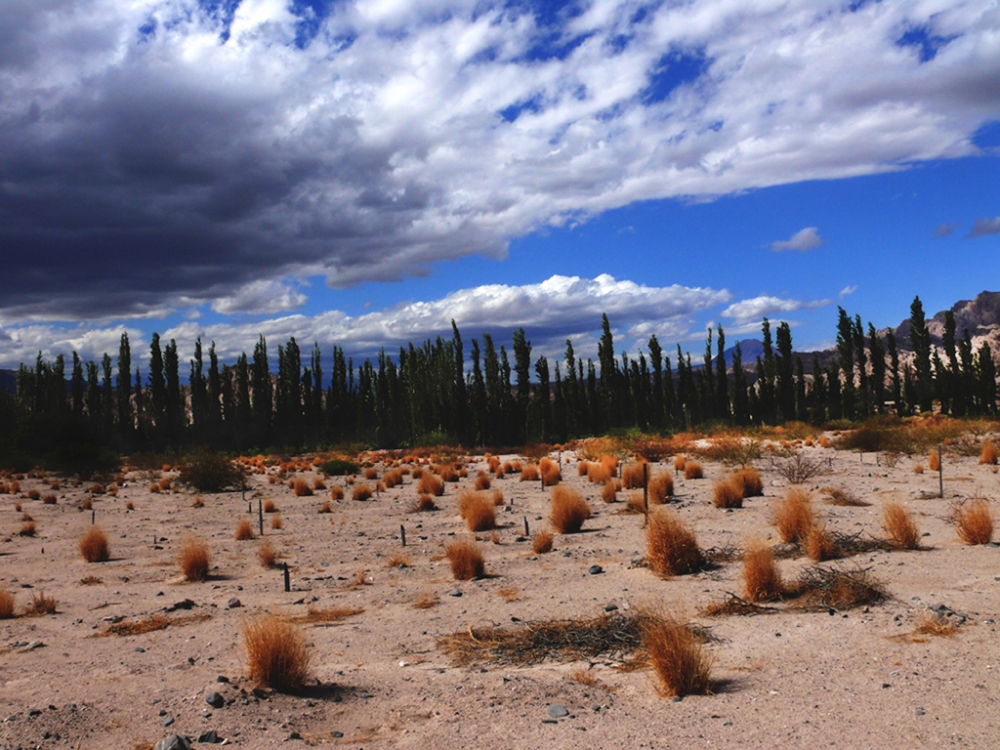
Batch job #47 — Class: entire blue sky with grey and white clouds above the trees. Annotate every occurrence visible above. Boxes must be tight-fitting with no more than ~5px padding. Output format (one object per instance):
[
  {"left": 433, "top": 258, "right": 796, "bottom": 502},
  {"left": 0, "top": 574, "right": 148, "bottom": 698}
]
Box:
[{"left": 0, "top": 0, "right": 1000, "bottom": 376}]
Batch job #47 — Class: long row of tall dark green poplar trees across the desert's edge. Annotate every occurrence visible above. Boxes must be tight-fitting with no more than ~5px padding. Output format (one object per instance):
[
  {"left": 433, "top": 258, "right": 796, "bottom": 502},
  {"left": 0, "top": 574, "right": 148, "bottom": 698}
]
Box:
[{"left": 0, "top": 298, "right": 996, "bottom": 454}]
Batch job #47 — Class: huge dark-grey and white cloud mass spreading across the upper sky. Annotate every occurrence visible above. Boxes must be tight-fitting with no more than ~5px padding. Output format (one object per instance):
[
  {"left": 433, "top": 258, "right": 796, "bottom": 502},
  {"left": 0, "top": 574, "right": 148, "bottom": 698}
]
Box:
[{"left": 0, "top": 0, "right": 1000, "bottom": 326}]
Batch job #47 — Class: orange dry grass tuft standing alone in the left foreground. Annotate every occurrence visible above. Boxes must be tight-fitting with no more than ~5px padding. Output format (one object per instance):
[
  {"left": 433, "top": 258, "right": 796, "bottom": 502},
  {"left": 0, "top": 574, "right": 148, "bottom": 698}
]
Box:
[{"left": 243, "top": 615, "right": 310, "bottom": 692}]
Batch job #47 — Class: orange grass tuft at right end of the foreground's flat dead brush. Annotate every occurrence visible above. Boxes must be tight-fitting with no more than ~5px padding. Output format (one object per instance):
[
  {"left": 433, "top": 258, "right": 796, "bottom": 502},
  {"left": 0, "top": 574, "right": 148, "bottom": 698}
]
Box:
[{"left": 640, "top": 612, "right": 713, "bottom": 696}]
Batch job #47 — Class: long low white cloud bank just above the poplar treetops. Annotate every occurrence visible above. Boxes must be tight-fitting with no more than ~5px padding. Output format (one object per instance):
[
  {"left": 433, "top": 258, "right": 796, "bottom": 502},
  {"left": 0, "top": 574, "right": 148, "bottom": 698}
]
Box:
[{"left": 0, "top": 275, "right": 731, "bottom": 367}]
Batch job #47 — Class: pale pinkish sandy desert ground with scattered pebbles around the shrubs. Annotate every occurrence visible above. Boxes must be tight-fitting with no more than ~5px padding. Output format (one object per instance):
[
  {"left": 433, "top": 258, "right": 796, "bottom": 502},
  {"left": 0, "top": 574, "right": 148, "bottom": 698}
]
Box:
[{"left": 0, "top": 438, "right": 1000, "bottom": 750}]
